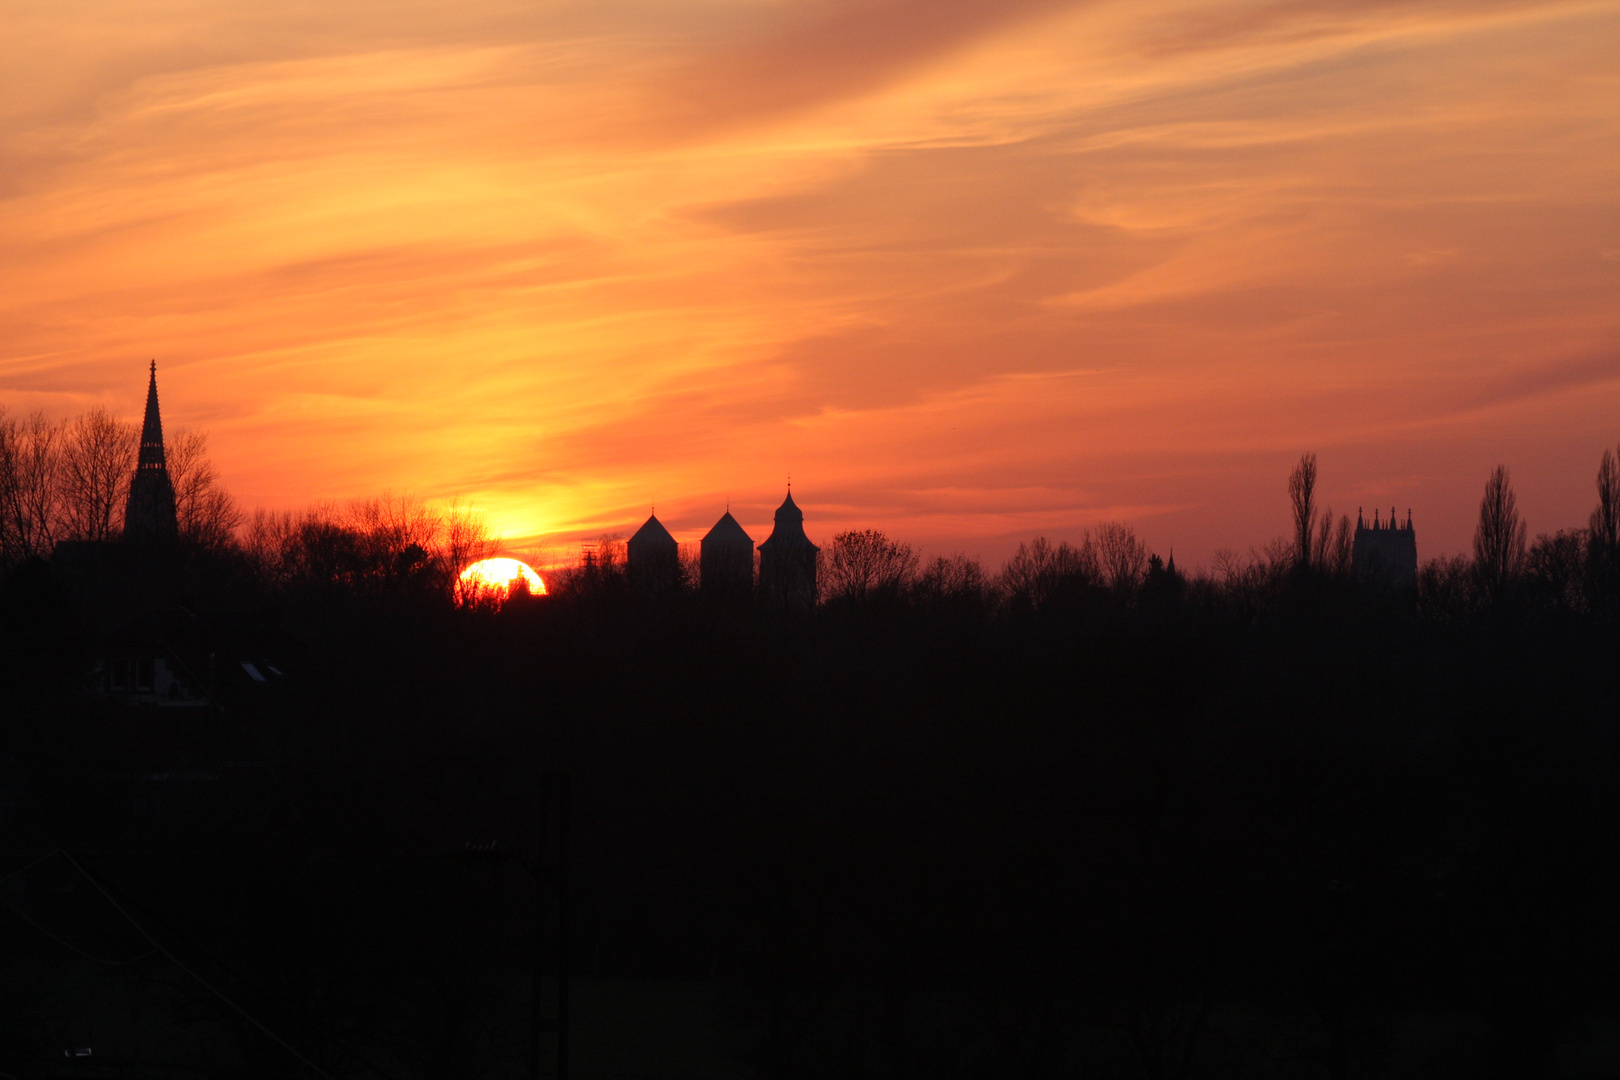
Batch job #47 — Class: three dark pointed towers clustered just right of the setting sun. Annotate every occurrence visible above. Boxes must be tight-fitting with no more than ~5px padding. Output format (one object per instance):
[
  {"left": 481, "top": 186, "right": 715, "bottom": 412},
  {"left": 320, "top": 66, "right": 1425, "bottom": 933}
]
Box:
[{"left": 625, "top": 489, "right": 821, "bottom": 609}]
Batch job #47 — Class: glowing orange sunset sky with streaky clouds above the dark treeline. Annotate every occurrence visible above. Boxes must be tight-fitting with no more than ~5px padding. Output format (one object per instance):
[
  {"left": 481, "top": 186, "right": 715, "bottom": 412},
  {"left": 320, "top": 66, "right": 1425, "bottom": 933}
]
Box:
[{"left": 0, "top": 0, "right": 1620, "bottom": 563}]
